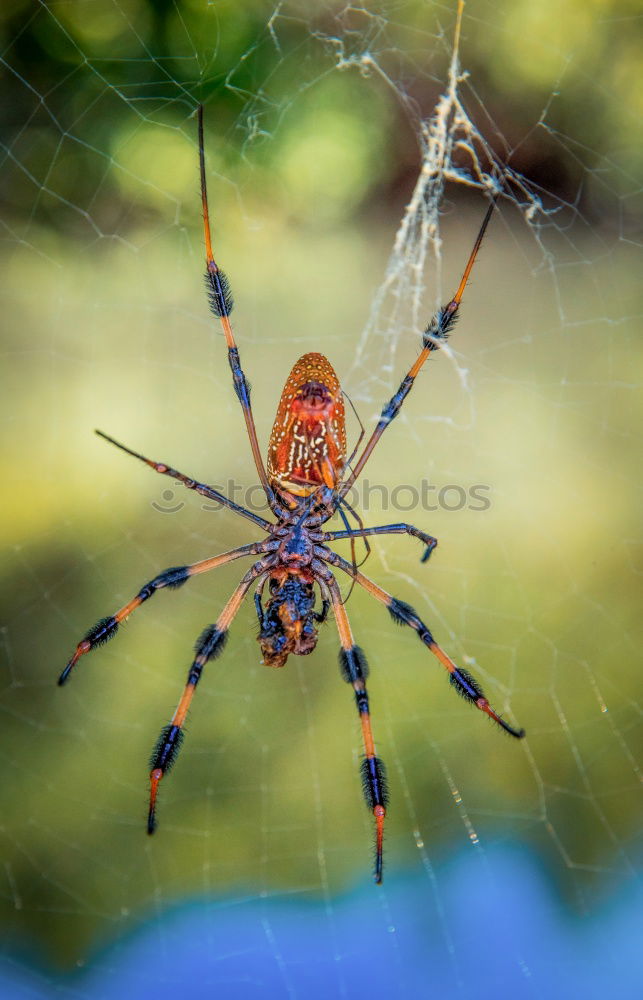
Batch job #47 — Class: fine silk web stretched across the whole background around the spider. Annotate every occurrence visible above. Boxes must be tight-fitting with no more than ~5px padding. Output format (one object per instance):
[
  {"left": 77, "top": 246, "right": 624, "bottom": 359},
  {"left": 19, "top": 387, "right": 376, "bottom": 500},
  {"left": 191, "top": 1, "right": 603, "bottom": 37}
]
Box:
[{"left": 0, "top": 0, "right": 641, "bottom": 998}]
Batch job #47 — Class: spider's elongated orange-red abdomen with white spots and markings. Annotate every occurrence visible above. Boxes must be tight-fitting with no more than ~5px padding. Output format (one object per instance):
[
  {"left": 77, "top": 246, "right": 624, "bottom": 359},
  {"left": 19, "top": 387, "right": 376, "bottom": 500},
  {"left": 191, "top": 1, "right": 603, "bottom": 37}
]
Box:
[{"left": 268, "top": 353, "right": 346, "bottom": 496}]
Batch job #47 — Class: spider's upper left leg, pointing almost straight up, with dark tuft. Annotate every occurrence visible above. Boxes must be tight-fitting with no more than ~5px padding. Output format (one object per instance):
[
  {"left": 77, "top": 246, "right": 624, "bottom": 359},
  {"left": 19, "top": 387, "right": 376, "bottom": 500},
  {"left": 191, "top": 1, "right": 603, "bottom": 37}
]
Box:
[{"left": 198, "top": 104, "right": 275, "bottom": 507}]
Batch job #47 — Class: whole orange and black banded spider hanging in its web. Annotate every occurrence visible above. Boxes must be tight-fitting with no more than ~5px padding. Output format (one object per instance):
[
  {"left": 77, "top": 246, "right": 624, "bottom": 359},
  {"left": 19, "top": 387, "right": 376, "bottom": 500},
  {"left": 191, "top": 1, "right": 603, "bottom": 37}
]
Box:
[{"left": 59, "top": 106, "right": 525, "bottom": 883}]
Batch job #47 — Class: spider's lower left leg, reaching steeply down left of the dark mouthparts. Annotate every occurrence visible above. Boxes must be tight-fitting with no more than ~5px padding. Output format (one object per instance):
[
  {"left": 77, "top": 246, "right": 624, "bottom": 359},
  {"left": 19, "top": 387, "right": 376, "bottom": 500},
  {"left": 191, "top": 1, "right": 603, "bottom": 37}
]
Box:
[{"left": 147, "top": 556, "right": 271, "bottom": 833}]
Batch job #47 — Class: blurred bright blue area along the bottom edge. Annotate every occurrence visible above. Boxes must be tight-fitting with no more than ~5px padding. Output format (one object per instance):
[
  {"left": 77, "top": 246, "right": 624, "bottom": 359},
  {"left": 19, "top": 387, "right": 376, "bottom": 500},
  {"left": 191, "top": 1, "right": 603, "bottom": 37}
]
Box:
[{"left": 0, "top": 849, "right": 643, "bottom": 1000}]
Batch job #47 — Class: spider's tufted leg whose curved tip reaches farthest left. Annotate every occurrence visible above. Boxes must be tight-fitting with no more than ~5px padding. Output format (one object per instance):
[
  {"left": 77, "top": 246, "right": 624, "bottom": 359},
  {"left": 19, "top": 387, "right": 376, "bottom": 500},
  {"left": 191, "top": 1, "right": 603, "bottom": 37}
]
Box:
[{"left": 58, "top": 542, "right": 278, "bottom": 685}]
